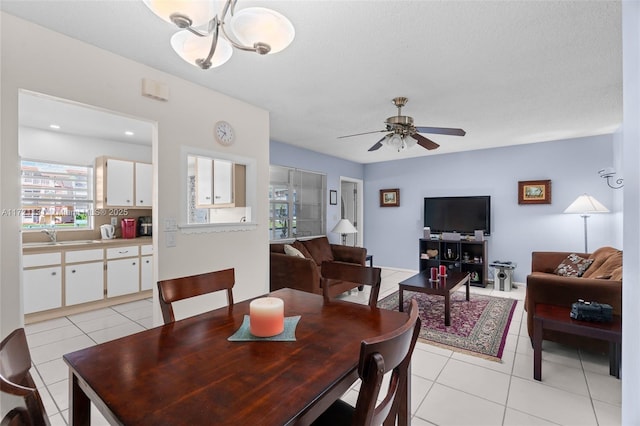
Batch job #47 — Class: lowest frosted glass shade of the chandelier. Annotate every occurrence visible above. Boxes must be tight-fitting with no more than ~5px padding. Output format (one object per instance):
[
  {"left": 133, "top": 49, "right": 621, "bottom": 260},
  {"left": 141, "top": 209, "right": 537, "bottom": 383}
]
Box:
[{"left": 171, "top": 30, "right": 233, "bottom": 68}]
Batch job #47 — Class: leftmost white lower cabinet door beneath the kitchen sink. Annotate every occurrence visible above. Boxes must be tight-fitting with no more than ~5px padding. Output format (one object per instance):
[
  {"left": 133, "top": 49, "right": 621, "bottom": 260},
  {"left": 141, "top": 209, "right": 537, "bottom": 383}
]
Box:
[{"left": 22, "top": 266, "right": 62, "bottom": 314}]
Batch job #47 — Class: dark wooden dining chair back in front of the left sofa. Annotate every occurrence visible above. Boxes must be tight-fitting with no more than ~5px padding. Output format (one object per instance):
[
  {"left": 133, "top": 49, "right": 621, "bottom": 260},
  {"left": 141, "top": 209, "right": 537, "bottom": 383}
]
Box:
[{"left": 320, "top": 262, "right": 382, "bottom": 308}]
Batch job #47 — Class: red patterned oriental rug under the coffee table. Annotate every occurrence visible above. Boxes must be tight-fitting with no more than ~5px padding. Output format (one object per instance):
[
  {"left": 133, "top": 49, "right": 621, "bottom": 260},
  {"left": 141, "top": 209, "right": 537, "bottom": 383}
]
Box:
[{"left": 378, "top": 291, "right": 517, "bottom": 362}]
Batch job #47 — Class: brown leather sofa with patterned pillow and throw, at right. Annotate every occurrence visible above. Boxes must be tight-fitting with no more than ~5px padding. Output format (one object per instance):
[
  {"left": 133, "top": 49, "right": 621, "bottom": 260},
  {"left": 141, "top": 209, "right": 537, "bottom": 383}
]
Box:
[{"left": 524, "top": 247, "right": 622, "bottom": 352}]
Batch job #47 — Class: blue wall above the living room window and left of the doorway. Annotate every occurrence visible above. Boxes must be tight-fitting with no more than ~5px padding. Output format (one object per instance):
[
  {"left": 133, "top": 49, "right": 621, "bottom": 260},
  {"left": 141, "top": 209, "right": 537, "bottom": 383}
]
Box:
[{"left": 269, "top": 141, "right": 364, "bottom": 244}]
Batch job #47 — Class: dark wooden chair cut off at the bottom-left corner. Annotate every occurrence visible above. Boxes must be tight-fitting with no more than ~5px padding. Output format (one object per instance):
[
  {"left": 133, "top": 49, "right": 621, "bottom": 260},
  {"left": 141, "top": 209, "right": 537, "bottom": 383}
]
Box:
[{"left": 0, "top": 328, "right": 50, "bottom": 426}]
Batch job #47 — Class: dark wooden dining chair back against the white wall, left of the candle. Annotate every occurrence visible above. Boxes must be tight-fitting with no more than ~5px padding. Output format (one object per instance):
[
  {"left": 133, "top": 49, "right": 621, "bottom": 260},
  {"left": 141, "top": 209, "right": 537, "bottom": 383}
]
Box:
[{"left": 158, "top": 268, "right": 236, "bottom": 324}]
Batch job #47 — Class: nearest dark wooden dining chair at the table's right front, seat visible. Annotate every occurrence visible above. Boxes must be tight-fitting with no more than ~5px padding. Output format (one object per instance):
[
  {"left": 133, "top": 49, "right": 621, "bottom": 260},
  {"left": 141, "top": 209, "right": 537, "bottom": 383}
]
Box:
[{"left": 313, "top": 300, "right": 420, "bottom": 426}]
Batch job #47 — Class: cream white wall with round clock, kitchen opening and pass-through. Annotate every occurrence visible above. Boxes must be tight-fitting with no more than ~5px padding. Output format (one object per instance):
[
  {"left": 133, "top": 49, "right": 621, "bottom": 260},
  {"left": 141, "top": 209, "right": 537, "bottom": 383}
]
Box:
[{"left": 0, "top": 13, "right": 269, "bottom": 336}]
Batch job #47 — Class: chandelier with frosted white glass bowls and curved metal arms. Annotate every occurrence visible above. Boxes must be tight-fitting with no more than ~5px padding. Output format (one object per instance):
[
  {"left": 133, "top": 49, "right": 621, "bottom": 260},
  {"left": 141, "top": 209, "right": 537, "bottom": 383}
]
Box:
[{"left": 143, "top": 0, "right": 295, "bottom": 70}]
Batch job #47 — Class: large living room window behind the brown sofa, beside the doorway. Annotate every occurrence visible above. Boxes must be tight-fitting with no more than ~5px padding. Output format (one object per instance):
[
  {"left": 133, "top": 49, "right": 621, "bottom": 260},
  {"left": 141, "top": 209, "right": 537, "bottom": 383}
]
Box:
[{"left": 269, "top": 166, "right": 327, "bottom": 240}]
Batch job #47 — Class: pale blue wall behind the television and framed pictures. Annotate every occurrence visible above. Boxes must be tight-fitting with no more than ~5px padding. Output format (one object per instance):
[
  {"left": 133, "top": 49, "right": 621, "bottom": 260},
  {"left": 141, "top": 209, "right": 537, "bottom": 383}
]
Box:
[{"left": 364, "top": 135, "right": 622, "bottom": 282}]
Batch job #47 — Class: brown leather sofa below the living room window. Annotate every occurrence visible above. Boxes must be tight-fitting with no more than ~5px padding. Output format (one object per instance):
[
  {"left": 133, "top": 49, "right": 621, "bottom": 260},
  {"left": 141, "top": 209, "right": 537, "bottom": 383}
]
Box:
[{"left": 269, "top": 237, "right": 367, "bottom": 294}]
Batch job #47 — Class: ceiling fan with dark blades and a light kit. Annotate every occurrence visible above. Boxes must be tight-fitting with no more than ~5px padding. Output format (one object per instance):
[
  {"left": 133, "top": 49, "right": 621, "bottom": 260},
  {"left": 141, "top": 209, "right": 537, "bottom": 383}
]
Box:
[{"left": 338, "top": 97, "right": 466, "bottom": 152}]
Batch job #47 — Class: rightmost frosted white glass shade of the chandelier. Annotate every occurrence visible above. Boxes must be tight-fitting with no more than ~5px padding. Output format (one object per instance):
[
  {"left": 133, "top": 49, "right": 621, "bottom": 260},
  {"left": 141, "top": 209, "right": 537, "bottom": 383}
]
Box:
[{"left": 230, "top": 7, "right": 296, "bottom": 54}]
